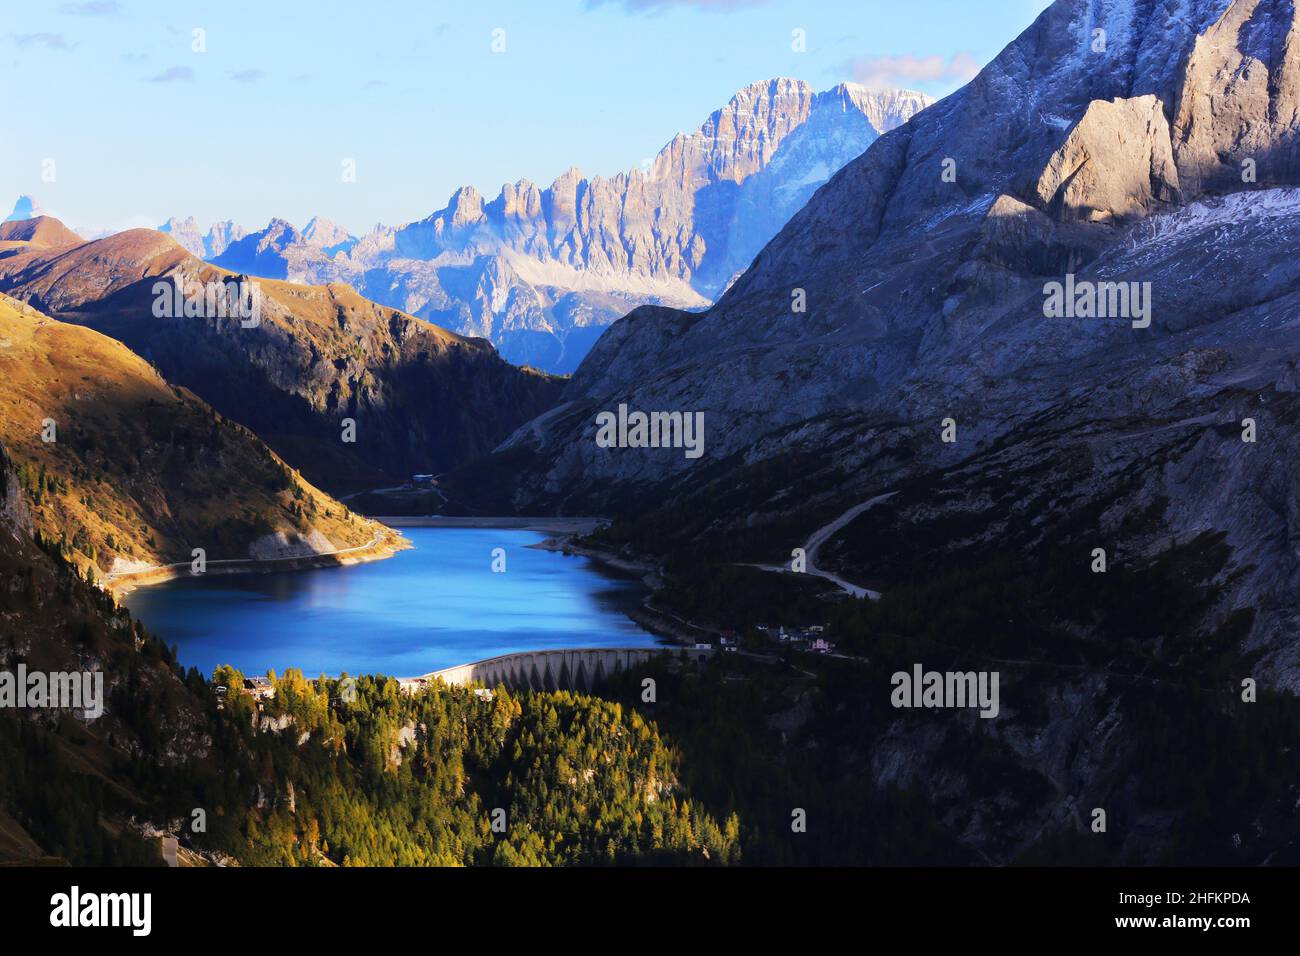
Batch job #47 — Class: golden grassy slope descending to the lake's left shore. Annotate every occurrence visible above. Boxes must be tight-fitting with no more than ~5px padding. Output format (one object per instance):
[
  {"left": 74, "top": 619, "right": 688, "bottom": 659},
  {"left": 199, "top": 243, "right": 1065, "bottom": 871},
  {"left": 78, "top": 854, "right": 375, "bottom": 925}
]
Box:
[{"left": 0, "top": 297, "right": 395, "bottom": 575}]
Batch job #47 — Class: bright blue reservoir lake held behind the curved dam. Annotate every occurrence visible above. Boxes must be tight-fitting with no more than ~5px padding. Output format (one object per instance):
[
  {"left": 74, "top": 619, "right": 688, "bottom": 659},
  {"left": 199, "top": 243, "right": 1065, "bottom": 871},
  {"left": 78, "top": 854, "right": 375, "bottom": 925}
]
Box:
[{"left": 125, "top": 528, "right": 659, "bottom": 678}]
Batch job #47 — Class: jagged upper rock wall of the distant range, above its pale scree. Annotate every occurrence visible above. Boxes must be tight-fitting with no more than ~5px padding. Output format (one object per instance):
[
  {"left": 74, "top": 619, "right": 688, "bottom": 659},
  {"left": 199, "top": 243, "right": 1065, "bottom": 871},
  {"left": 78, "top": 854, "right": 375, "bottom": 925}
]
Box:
[{"left": 379, "top": 79, "right": 927, "bottom": 298}]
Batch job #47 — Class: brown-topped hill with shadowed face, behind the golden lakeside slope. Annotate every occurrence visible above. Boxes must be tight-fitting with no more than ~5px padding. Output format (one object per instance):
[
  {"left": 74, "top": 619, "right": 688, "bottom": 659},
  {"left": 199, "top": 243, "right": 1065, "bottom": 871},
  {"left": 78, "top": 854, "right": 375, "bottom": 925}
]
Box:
[{"left": 0, "top": 226, "right": 563, "bottom": 492}]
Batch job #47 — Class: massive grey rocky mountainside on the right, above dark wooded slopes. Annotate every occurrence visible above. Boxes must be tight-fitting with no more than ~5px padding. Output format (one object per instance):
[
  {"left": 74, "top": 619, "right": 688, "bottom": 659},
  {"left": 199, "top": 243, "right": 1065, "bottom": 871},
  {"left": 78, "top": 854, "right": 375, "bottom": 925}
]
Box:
[{"left": 480, "top": 0, "right": 1300, "bottom": 687}]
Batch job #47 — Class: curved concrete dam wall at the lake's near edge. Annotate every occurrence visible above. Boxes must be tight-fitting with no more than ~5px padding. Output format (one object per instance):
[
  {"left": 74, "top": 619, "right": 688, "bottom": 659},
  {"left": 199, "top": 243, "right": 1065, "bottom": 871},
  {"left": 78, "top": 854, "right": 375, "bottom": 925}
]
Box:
[{"left": 420, "top": 646, "right": 712, "bottom": 692}]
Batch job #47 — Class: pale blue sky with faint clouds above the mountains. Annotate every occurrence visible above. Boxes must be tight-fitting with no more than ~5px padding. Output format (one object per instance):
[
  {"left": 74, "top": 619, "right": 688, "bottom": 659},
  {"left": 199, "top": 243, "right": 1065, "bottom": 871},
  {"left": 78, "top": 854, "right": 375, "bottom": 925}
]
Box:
[{"left": 0, "top": 0, "right": 1048, "bottom": 232}]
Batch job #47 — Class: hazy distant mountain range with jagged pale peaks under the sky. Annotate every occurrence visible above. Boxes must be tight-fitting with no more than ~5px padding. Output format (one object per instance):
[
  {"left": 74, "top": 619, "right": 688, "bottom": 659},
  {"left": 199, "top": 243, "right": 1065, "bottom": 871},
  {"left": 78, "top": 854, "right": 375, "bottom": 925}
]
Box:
[{"left": 161, "top": 78, "right": 930, "bottom": 373}]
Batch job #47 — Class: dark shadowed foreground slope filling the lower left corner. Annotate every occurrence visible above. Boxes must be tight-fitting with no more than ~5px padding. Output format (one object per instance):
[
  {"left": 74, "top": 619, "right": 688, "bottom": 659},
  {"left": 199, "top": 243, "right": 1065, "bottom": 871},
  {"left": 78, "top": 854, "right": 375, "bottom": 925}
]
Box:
[{"left": 0, "top": 442, "right": 212, "bottom": 864}]
